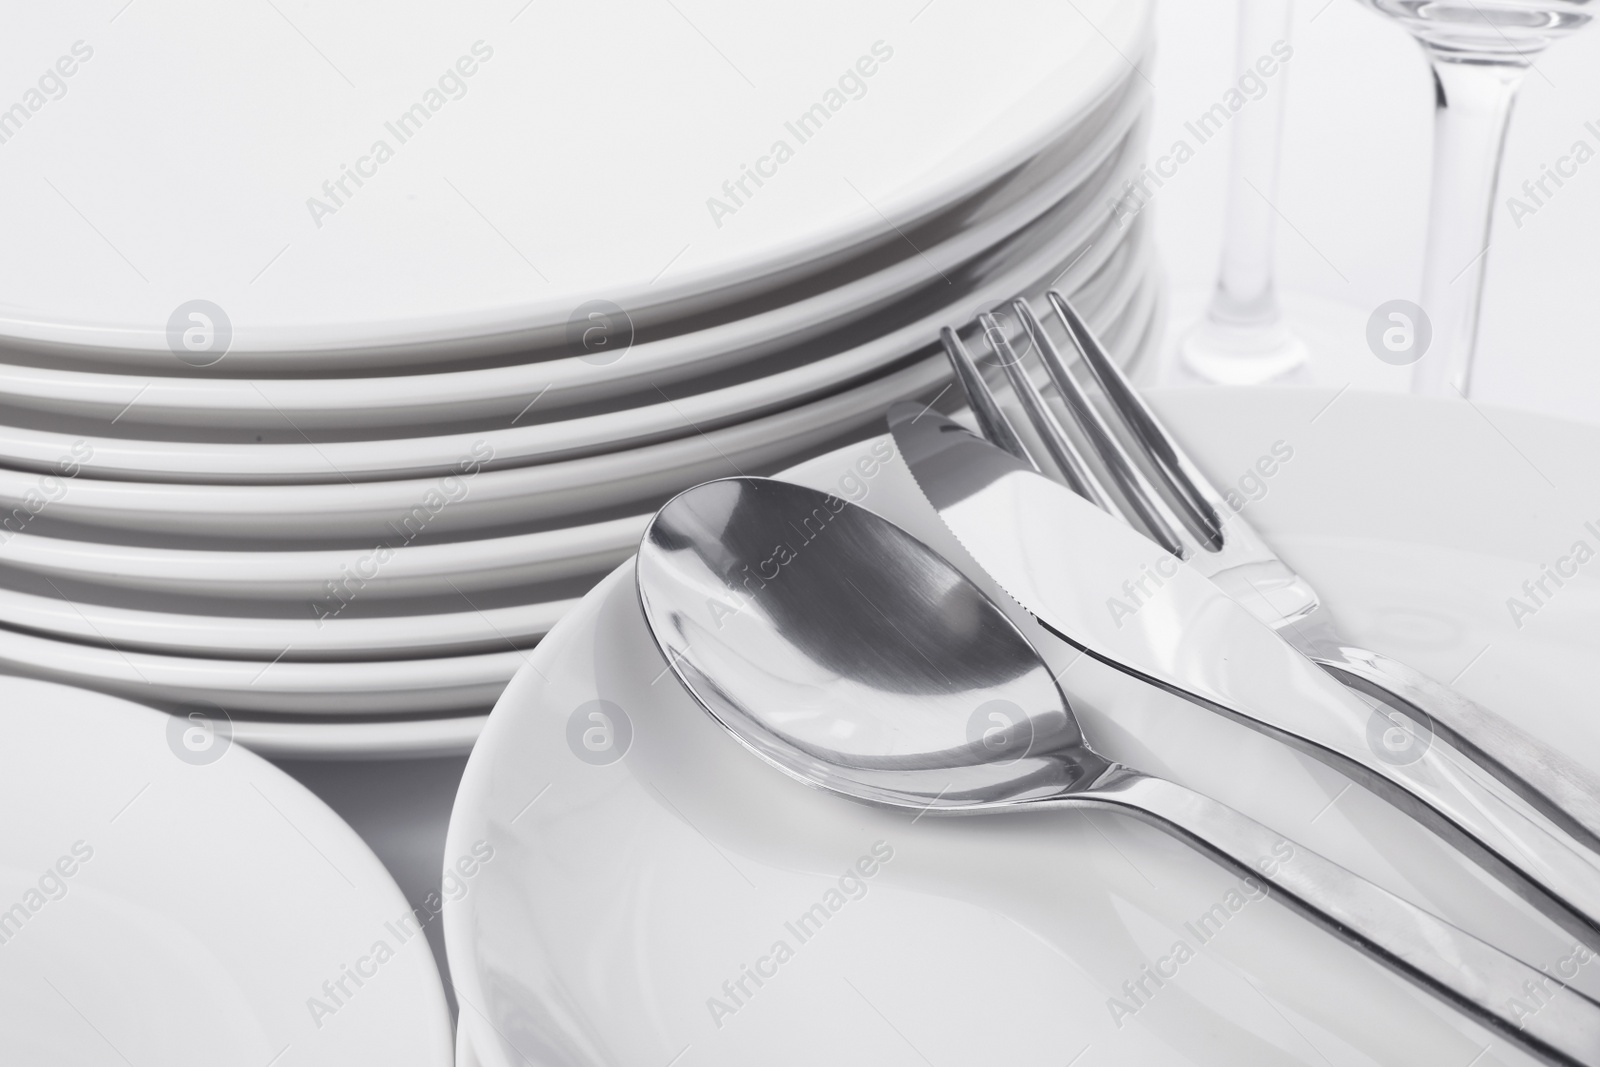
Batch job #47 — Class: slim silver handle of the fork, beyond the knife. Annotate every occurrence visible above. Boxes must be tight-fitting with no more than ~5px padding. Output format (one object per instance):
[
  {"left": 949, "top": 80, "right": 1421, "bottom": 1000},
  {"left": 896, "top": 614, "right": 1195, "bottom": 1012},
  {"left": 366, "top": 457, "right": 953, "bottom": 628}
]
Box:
[{"left": 1312, "top": 643, "right": 1600, "bottom": 854}]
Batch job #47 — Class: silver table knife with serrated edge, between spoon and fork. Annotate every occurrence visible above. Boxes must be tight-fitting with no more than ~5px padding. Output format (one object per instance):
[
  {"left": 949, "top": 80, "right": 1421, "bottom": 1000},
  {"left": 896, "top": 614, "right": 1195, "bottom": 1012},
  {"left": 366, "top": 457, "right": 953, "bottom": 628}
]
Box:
[{"left": 890, "top": 405, "right": 1600, "bottom": 947}]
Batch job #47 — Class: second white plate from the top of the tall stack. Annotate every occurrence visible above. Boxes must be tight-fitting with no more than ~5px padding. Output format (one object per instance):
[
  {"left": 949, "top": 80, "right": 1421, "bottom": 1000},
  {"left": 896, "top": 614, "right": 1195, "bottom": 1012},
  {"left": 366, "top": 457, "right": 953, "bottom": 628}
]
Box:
[{"left": 0, "top": 75, "right": 1147, "bottom": 430}]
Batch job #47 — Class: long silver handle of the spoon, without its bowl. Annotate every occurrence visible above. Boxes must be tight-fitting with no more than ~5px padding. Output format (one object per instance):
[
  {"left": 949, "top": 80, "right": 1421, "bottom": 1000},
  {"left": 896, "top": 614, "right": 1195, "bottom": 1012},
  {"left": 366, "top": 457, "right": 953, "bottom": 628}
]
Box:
[{"left": 1070, "top": 766, "right": 1600, "bottom": 1067}]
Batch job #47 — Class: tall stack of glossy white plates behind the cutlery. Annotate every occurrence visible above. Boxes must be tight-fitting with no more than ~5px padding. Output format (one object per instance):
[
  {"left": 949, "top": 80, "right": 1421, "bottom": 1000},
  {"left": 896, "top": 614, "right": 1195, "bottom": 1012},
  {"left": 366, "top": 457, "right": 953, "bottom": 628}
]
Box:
[{"left": 0, "top": 0, "right": 1158, "bottom": 752}]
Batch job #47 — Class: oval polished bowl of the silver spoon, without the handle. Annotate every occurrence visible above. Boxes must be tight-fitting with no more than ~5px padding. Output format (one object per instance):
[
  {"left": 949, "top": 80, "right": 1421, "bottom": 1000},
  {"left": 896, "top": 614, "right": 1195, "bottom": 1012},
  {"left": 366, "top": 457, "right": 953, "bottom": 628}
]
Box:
[{"left": 637, "top": 478, "right": 1110, "bottom": 811}]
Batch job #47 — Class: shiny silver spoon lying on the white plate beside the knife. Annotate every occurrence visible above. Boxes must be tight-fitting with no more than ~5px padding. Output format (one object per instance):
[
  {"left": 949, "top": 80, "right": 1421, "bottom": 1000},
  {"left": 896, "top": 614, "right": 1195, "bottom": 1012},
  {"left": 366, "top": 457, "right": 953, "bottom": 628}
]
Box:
[{"left": 637, "top": 478, "right": 1600, "bottom": 1064}]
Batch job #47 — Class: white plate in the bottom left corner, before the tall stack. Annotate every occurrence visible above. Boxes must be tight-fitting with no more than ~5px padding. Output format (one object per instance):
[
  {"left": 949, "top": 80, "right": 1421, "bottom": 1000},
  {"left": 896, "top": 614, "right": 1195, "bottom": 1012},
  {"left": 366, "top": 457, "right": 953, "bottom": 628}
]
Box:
[{"left": 0, "top": 678, "right": 454, "bottom": 1067}]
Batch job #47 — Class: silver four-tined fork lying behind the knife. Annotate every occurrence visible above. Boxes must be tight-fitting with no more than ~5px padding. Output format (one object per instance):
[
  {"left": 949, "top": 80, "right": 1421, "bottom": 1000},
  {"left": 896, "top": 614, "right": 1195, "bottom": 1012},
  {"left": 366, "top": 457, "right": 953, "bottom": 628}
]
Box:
[{"left": 941, "top": 290, "right": 1600, "bottom": 857}]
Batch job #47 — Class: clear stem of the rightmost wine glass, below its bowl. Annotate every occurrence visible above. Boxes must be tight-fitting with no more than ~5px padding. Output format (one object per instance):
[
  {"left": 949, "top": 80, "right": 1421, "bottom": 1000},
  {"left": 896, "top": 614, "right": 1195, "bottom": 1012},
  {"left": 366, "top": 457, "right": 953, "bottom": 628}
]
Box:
[{"left": 1411, "top": 54, "right": 1526, "bottom": 397}]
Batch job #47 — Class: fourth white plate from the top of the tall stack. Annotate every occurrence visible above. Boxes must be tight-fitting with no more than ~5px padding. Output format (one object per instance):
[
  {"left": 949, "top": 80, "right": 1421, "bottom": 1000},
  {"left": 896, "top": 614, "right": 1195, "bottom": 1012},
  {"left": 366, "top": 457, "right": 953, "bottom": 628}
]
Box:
[{"left": 0, "top": 219, "right": 1149, "bottom": 541}]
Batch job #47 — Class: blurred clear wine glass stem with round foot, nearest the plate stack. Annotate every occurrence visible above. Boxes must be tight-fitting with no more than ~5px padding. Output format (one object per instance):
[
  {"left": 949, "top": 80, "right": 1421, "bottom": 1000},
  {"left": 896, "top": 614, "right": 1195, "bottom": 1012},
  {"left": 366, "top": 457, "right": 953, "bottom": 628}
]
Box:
[{"left": 1179, "top": 0, "right": 1306, "bottom": 386}]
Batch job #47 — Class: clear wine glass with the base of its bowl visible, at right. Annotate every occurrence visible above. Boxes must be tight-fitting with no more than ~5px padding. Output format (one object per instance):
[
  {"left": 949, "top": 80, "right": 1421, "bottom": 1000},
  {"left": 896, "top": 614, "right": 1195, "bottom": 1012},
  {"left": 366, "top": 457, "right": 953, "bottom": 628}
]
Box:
[{"left": 1362, "top": 0, "right": 1594, "bottom": 397}]
